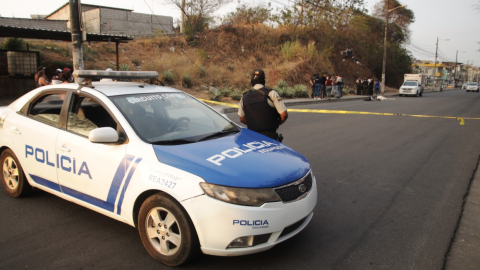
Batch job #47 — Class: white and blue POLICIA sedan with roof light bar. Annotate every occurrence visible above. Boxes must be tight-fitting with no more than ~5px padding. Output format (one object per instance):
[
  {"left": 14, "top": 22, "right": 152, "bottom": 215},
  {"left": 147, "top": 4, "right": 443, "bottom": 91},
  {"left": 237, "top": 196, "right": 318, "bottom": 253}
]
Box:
[{"left": 0, "top": 71, "right": 317, "bottom": 266}]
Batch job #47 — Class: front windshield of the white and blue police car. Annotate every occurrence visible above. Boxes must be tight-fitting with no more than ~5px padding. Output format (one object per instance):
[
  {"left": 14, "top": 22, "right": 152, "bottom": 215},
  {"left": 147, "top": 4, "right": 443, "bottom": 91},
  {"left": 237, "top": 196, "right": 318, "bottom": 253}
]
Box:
[{"left": 111, "top": 93, "right": 238, "bottom": 145}]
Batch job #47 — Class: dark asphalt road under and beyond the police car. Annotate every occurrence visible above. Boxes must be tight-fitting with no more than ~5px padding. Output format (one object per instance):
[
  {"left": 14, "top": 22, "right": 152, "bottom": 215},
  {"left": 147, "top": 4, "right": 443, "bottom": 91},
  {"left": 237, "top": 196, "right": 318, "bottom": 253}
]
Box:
[{"left": 0, "top": 90, "right": 480, "bottom": 270}]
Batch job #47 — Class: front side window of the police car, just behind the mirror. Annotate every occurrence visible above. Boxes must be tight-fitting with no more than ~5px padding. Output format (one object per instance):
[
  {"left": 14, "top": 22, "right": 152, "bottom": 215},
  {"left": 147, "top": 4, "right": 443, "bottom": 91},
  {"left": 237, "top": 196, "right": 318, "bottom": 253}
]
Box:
[{"left": 67, "top": 95, "right": 117, "bottom": 137}]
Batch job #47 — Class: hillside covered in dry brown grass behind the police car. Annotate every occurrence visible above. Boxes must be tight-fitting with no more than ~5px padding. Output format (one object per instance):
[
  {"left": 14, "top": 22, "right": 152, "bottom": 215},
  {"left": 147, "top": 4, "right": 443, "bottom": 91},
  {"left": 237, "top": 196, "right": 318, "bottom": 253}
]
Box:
[{"left": 24, "top": 26, "right": 396, "bottom": 99}]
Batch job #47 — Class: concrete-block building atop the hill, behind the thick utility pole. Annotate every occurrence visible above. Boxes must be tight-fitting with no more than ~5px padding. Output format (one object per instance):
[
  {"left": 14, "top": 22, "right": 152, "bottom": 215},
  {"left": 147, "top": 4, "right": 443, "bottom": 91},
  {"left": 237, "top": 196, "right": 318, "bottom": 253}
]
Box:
[{"left": 45, "top": 3, "right": 173, "bottom": 36}]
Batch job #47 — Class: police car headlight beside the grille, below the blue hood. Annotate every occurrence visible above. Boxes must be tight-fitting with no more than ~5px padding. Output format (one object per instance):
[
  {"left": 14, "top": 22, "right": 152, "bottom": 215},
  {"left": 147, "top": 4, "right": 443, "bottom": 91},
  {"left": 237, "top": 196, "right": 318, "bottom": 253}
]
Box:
[{"left": 200, "top": 183, "right": 280, "bottom": 206}]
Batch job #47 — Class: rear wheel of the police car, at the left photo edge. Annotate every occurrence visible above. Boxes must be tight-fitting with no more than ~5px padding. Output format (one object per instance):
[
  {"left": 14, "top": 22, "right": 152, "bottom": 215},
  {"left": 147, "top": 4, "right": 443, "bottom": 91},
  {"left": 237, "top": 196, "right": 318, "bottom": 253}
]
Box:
[{"left": 0, "top": 149, "right": 33, "bottom": 198}]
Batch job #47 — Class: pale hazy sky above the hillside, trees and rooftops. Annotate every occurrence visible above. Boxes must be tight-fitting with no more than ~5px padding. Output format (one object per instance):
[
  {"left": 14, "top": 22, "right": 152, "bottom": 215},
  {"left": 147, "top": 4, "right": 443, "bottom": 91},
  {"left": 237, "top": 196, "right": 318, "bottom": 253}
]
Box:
[{"left": 0, "top": 0, "right": 480, "bottom": 66}]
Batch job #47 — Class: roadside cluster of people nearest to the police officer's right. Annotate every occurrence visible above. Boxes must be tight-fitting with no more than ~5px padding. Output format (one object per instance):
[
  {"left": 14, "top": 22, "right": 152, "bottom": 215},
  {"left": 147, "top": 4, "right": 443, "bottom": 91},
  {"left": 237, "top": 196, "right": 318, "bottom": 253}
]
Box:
[{"left": 310, "top": 72, "right": 343, "bottom": 99}]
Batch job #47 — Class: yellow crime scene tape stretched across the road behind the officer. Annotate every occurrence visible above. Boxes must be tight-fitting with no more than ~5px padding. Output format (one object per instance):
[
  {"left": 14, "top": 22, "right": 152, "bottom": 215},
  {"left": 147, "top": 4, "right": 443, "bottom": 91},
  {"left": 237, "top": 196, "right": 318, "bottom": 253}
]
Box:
[{"left": 200, "top": 99, "right": 480, "bottom": 126}]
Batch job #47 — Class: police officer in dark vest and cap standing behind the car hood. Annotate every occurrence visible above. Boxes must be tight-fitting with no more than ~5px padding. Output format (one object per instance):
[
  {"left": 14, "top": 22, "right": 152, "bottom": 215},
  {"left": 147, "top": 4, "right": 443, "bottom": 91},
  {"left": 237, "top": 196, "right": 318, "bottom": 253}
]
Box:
[{"left": 238, "top": 69, "right": 288, "bottom": 142}]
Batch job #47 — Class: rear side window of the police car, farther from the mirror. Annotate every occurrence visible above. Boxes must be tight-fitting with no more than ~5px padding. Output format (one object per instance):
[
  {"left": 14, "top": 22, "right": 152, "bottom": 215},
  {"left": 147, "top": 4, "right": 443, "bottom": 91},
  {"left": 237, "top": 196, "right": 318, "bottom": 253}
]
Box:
[{"left": 28, "top": 93, "right": 65, "bottom": 126}]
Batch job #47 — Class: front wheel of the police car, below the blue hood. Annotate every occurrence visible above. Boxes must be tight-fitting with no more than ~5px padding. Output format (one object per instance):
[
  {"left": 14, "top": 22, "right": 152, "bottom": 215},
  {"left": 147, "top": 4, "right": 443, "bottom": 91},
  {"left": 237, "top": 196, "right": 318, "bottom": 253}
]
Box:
[{"left": 138, "top": 193, "right": 200, "bottom": 266}]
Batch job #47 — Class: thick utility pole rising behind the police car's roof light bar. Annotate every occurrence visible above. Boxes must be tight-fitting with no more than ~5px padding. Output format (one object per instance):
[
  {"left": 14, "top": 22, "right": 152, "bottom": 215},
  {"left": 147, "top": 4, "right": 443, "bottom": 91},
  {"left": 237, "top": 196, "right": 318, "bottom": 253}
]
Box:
[{"left": 69, "top": 0, "right": 83, "bottom": 75}]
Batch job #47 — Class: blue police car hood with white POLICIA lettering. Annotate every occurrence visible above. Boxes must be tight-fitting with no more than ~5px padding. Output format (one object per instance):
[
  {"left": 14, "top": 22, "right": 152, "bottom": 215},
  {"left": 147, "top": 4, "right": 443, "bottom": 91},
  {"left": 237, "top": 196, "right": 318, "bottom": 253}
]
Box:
[{"left": 153, "top": 129, "right": 310, "bottom": 188}]
